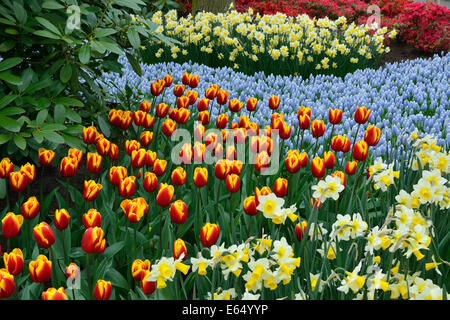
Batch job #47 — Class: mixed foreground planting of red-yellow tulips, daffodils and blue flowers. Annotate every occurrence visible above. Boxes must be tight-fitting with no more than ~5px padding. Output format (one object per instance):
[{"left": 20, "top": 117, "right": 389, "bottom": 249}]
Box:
[{"left": 0, "top": 51, "right": 450, "bottom": 299}]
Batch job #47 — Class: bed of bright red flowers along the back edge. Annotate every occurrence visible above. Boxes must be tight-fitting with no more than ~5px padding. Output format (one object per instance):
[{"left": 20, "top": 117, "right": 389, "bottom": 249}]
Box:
[{"left": 236, "top": 0, "right": 450, "bottom": 53}]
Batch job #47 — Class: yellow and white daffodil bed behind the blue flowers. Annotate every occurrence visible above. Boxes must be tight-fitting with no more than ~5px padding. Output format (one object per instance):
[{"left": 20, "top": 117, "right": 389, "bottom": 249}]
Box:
[{"left": 136, "top": 10, "right": 395, "bottom": 76}]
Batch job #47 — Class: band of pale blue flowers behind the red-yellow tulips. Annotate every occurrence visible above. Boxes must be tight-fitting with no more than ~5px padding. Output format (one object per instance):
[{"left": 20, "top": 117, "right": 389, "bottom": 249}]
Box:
[{"left": 104, "top": 55, "right": 450, "bottom": 162}]
